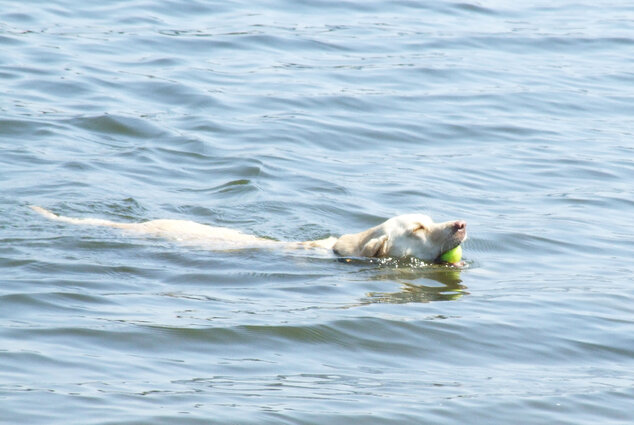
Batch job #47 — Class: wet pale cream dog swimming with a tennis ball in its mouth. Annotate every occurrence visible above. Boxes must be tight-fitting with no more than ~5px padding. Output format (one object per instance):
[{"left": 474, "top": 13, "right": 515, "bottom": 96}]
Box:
[{"left": 31, "top": 206, "right": 467, "bottom": 261}]
